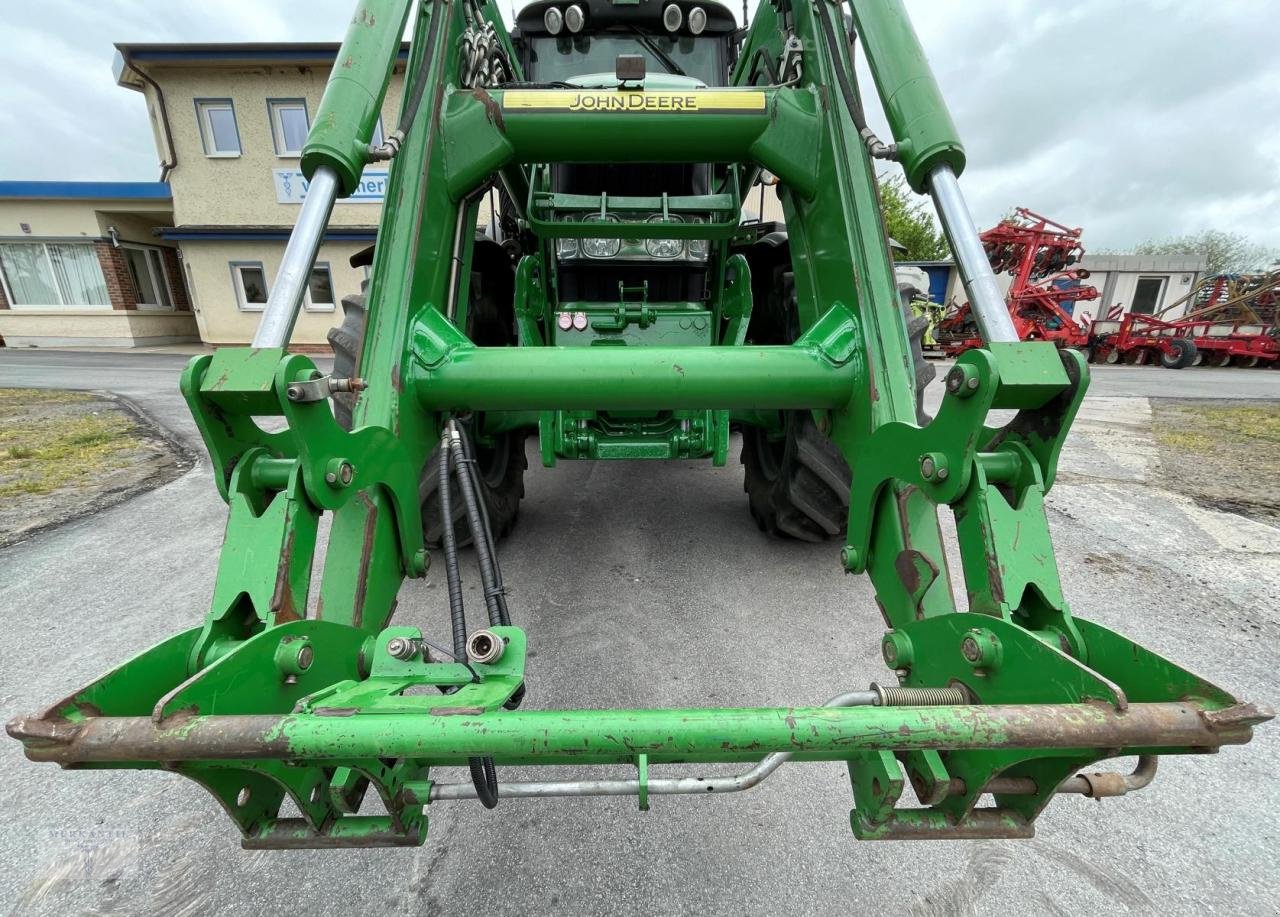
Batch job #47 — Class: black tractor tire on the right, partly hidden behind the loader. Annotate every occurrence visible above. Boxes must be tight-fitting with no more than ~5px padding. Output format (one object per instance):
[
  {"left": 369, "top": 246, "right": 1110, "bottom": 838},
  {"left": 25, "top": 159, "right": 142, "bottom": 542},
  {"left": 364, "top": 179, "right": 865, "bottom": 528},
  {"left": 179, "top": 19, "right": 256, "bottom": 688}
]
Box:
[{"left": 742, "top": 266, "right": 937, "bottom": 542}]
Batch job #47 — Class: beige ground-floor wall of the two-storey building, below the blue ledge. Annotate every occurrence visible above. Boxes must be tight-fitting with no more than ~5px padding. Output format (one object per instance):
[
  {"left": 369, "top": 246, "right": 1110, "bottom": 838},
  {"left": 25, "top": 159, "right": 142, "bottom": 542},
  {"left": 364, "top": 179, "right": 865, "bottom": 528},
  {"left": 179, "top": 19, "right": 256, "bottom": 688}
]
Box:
[{"left": 182, "top": 241, "right": 367, "bottom": 346}]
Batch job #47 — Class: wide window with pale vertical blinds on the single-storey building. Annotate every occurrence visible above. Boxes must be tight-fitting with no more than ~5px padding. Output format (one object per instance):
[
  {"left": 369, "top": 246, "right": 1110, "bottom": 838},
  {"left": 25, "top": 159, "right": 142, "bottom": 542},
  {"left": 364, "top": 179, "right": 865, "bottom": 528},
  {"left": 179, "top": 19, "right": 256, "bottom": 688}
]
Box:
[{"left": 0, "top": 242, "right": 111, "bottom": 309}]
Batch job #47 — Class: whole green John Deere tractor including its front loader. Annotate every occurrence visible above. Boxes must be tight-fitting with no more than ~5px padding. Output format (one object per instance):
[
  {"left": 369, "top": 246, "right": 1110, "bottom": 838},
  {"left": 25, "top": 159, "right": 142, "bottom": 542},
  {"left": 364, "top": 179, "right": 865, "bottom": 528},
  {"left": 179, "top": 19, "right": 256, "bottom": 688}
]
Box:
[{"left": 9, "top": 0, "right": 1272, "bottom": 848}]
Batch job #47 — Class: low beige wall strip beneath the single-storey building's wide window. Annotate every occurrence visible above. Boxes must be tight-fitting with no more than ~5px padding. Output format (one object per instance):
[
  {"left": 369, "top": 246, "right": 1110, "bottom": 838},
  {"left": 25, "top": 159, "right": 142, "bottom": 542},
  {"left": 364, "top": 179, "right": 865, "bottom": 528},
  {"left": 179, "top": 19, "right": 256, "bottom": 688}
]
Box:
[{"left": 0, "top": 309, "right": 198, "bottom": 347}]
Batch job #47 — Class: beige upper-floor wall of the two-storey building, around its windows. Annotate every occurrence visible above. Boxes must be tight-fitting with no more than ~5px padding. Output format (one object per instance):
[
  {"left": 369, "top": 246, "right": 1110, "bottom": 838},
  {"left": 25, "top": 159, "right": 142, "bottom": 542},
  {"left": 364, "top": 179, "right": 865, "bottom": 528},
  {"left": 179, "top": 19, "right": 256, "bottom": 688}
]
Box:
[{"left": 140, "top": 67, "right": 402, "bottom": 225}]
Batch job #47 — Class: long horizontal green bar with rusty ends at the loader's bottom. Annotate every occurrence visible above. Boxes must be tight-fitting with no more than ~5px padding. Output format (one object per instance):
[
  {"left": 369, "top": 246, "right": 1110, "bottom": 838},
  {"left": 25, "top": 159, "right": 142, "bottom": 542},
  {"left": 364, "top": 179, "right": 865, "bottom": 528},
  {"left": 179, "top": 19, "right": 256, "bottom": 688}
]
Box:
[{"left": 8, "top": 702, "right": 1274, "bottom": 765}]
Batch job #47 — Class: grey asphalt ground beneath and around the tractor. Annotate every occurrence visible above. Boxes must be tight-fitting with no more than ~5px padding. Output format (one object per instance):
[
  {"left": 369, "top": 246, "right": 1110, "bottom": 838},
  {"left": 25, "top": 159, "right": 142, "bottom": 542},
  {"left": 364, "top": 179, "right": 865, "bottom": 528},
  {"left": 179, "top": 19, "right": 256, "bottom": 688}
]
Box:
[{"left": 0, "top": 351, "right": 1280, "bottom": 914}]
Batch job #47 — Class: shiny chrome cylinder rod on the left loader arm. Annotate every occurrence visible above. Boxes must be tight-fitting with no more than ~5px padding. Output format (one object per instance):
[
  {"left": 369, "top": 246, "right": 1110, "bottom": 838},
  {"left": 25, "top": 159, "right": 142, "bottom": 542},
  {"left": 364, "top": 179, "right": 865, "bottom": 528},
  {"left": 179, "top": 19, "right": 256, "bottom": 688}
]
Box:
[{"left": 253, "top": 165, "right": 338, "bottom": 347}]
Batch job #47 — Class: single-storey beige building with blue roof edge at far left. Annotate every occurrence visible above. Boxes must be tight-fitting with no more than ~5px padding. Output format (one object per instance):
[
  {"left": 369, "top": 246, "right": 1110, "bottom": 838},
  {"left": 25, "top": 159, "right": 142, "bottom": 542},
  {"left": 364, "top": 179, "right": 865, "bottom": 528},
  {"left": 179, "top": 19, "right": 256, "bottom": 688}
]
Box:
[{"left": 0, "top": 182, "right": 200, "bottom": 347}]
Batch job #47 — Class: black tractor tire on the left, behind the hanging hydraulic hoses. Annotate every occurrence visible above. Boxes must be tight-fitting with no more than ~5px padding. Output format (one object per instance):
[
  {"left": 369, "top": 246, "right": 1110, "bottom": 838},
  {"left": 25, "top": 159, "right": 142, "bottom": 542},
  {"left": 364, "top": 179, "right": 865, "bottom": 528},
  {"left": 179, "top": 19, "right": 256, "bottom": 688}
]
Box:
[{"left": 328, "top": 286, "right": 529, "bottom": 548}]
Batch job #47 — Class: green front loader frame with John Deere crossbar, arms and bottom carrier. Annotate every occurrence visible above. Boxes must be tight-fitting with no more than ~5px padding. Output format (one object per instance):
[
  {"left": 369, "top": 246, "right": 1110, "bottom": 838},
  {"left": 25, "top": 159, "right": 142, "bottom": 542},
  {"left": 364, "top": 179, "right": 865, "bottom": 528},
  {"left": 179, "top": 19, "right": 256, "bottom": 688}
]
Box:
[{"left": 9, "top": 0, "right": 1271, "bottom": 848}]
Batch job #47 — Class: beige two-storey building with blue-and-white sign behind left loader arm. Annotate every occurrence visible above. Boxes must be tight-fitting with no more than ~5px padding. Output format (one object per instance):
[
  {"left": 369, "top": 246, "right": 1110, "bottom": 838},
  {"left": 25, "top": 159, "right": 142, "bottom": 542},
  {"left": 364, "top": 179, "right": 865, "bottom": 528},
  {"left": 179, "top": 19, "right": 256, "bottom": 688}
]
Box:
[{"left": 115, "top": 44, "right": 407, "bottom": 347}]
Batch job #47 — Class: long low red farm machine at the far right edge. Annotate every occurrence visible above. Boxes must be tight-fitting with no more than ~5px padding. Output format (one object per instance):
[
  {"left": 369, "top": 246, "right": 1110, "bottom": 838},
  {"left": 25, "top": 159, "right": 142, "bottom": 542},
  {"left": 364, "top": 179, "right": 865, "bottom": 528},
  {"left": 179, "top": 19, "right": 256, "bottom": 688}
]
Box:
[{"left": 1091, "top": 270, "right": 1280, "bottom": 369}]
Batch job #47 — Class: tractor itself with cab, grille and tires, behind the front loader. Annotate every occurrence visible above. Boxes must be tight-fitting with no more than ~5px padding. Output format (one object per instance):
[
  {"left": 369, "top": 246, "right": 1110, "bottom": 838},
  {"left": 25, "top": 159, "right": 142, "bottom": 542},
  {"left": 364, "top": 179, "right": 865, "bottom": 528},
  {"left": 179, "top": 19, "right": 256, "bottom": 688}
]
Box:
[{"left": 329, "top": 0, "right": 934, "bottom": 547}]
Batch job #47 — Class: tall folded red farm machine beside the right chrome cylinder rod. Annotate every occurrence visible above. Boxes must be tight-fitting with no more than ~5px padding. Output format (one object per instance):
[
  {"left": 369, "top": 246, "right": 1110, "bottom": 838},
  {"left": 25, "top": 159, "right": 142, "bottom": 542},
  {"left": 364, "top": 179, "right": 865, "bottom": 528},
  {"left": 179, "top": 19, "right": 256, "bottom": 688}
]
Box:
[{"left": 934, "top": 207, "right": 1098, "bottom": 356}]
